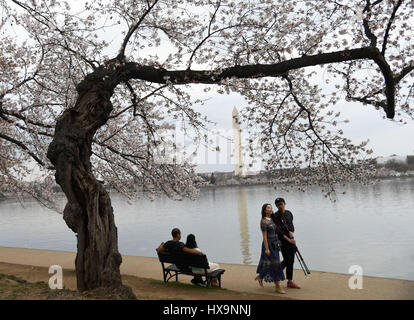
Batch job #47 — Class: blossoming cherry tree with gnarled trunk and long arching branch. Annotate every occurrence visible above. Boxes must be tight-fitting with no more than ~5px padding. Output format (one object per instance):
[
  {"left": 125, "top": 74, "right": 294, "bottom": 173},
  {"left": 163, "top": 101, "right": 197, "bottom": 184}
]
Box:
[{"left": 0, "top": 0, "right": 414, "bottom": 295}]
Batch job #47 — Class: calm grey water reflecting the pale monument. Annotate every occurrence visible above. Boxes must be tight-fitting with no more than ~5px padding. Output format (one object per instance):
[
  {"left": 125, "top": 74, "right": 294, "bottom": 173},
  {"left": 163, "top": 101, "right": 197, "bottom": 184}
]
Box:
[{"left": 0, "top": 179, "right": 414, "bottom": 280}]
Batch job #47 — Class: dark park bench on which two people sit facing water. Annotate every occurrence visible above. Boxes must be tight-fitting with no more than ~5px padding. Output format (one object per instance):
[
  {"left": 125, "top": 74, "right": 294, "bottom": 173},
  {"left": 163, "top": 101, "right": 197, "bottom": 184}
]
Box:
[{"left": 158, "top": 252, "right": 225, "bottom": 288}]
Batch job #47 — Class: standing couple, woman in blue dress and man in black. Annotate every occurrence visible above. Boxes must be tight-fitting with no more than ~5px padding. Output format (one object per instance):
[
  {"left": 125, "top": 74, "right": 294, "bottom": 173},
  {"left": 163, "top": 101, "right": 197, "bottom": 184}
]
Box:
[{"left": 255, "top": 198, "right": 300, "bottom": 293}]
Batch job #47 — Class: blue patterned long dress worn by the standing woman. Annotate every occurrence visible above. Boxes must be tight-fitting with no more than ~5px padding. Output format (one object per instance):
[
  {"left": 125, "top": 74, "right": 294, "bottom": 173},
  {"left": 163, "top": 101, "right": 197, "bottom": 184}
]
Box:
[{"left": 256, "top": 219, "right": 285, "bottom": 282}]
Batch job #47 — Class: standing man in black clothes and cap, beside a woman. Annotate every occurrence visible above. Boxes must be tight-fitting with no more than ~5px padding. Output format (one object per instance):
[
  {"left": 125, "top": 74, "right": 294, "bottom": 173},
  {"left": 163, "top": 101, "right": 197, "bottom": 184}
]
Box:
[{"left": 272, "top": 198, "right": 300, "bottom": 289}]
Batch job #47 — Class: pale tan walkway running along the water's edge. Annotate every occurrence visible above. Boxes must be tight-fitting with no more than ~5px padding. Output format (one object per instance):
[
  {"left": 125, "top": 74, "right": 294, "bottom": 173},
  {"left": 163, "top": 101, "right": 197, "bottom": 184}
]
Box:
[{"left": 0, "top": 247, "right": 414, "bottom": 300}]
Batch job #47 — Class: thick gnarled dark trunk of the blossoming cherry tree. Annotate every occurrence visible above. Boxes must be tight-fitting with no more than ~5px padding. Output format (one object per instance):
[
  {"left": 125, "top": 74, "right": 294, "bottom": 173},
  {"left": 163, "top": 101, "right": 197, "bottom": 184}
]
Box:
[{"left": 47, "top": 78, "right": 134, "bottom": 297}]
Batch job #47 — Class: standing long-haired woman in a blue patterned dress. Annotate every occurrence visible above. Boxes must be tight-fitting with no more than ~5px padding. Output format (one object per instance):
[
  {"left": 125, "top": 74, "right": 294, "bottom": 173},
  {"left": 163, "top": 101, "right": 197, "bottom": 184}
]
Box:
[{"left": 255, "top": 203, "right": 286, "bottom": 293}]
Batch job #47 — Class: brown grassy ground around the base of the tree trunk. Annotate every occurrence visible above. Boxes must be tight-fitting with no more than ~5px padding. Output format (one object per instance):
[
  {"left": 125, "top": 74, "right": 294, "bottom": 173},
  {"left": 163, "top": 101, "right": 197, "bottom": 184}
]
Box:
[{"left": 0, "top": 262, "right": 284, "bottom": 300}]
